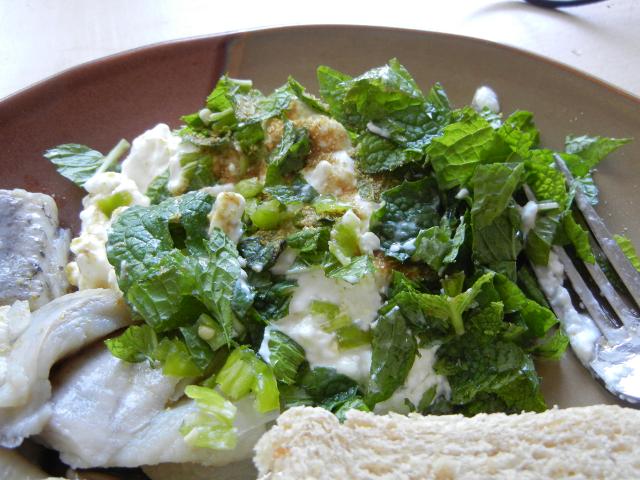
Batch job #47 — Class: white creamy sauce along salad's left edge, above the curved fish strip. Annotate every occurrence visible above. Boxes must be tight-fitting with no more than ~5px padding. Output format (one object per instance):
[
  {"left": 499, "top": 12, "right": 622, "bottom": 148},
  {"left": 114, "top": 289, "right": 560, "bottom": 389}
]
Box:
[{"left": 66, "top": 173, "right": 149, "bottom": 290}]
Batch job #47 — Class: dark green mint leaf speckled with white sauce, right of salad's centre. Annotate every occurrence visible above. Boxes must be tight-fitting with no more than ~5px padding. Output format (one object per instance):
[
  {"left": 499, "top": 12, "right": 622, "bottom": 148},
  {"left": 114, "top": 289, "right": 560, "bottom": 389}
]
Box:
[{"left": 371, "top": 177, "right": 440, "bottom": 261}]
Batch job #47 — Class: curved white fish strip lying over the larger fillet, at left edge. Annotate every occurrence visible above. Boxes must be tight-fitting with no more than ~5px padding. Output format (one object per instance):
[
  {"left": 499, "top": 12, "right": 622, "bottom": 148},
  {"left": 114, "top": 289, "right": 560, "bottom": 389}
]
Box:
[{"left": 0, "top": 289, "right": 130, "bottom": 447}]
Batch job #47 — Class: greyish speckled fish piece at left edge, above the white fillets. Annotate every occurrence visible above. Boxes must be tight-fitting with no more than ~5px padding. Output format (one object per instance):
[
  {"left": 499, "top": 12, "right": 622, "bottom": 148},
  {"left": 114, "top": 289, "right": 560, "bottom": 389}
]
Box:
[{"left": 0, "top": 189, "right": 70, "bottom": 310}]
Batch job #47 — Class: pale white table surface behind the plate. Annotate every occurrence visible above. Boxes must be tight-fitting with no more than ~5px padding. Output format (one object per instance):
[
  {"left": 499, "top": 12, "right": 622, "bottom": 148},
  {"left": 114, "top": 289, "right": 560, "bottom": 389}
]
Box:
[{"left": 0, "top": 0, "right": 640, "bottom": 98}]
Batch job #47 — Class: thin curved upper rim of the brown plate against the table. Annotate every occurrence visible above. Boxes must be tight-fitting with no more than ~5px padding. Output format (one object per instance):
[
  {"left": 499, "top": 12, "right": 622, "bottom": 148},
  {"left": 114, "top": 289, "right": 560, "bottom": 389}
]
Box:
[{"left": 0, "top": 23, "right": 640, "bottom": 110}]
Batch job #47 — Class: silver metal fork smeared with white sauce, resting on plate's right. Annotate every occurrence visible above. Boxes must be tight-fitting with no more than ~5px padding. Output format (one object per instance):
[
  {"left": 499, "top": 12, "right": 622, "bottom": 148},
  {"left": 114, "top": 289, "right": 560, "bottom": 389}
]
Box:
[{"left": 525, "top": 155, "right": 640, "bottom": 407}]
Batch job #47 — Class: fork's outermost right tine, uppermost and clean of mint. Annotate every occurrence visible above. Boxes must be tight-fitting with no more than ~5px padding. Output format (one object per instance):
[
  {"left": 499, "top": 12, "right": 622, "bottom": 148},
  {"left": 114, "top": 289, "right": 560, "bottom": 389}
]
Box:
[{"left": 554, "top": 154, "right": 640, "bottom": 308}]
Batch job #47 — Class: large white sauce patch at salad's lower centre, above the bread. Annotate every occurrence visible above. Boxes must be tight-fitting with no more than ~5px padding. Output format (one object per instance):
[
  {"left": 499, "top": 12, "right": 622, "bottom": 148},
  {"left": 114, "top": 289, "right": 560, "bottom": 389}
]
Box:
[{"left": 260, "top": 269, "right": 384, "bottom": 382}]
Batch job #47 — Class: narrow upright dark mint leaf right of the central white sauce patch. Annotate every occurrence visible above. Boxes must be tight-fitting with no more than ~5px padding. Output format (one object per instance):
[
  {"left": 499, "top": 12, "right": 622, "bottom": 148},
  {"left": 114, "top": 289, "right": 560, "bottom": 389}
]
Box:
[{"left": 365, "top": 307, "right": 418, "bottom": 407}]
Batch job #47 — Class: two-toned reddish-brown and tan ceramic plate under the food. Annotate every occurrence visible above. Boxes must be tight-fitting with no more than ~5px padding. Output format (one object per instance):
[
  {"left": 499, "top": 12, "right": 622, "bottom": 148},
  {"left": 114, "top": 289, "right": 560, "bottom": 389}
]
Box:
[{"left": 0, "top": 26, "right": 640, "bottom": 476}]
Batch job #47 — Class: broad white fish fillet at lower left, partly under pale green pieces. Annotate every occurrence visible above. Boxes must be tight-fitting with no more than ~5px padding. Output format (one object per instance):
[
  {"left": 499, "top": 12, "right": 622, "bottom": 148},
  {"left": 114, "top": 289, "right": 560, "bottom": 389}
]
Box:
[{"left": 40, "top": 346, "right": 274, "bottom": 468}]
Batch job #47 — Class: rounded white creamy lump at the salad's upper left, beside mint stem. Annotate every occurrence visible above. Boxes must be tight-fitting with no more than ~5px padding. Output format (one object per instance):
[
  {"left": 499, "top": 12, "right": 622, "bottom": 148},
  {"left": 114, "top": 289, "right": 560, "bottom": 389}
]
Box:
[{"left": 122, "top": 123, "right": 182, "bottom": 193}]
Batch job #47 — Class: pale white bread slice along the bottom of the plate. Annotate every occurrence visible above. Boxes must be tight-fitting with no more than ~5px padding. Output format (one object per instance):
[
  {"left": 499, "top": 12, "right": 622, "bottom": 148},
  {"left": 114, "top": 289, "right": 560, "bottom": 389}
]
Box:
[{"left": 254, "top": 405, "right": 640, "bottom": 480}]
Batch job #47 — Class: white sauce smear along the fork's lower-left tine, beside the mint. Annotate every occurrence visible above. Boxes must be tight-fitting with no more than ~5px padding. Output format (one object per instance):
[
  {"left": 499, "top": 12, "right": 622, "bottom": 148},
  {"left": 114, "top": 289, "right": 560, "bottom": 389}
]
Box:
[{"left": 535, "top": 252, "right": 602, "bottom": 366}]
